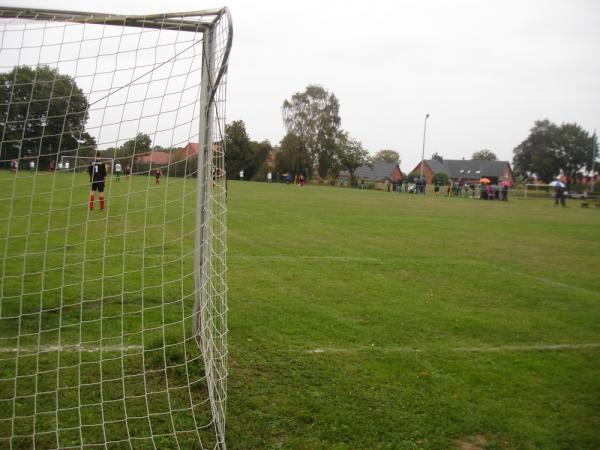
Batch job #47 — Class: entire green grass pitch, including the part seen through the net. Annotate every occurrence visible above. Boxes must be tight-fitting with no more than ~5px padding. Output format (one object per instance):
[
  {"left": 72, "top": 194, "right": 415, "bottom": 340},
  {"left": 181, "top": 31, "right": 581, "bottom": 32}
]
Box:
[{"left": 0, "top": 172, "right": 600, "bottom": 449}]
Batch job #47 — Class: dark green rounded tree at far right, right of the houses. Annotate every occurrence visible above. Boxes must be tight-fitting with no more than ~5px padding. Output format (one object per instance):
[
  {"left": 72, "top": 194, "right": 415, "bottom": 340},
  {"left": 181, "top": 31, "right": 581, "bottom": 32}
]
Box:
[{"left": 513, "top": 119, "right": 593, "bottom": 187}]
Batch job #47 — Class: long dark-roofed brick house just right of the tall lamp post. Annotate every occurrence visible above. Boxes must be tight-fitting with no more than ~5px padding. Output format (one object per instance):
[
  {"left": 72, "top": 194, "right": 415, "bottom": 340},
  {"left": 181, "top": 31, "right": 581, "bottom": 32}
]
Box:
[{"left": 411, "top": 159, "right": 514, "bottom": 183}]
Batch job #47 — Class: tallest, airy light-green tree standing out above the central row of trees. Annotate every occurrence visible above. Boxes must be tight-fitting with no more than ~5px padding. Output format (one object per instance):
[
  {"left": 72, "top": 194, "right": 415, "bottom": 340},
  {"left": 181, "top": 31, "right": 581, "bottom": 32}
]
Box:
[{"left": 282, "top": 85, "right": 341, "bottom": 177}]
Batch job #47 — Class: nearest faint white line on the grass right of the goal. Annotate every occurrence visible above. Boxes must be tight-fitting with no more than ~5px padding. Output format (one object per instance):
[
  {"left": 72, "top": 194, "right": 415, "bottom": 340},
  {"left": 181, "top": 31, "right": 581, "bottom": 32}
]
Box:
[{"left": 307, "top": 342, "right": 600, "bottom": 353}]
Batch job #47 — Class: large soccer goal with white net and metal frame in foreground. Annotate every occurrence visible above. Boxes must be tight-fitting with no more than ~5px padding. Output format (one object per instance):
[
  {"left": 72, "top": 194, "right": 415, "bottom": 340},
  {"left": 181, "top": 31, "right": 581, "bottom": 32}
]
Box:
[{"left": 0, "top": 7, "right": 232, "bottom": 449}]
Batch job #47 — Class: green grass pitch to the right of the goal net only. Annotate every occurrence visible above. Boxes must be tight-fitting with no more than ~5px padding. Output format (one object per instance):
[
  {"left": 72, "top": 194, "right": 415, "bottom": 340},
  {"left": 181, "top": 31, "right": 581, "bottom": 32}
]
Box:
[{"left": 223, "top": 182, "right": 600, "bottom": 449}]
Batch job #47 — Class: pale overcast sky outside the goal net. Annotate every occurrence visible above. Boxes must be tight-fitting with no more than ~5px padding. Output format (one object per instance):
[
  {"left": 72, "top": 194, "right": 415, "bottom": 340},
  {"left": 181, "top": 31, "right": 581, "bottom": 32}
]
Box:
[{"left": 4, "top": 0, "right": 600, "bottom": 172}]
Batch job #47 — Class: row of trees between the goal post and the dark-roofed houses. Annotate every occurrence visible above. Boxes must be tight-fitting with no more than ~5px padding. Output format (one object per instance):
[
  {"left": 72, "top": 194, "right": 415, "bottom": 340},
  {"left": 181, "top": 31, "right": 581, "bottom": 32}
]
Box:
[{"left": 225, "top": 85, "right": 400, "bottom": 185}]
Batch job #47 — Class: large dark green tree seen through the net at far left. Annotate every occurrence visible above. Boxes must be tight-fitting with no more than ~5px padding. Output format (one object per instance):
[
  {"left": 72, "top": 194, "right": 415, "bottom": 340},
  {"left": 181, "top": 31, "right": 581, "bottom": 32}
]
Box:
[{"left": 0, "top": 66, "right": 96, "bottom": 167}]
